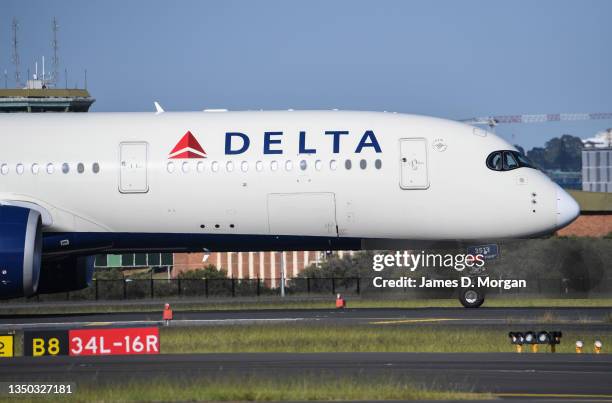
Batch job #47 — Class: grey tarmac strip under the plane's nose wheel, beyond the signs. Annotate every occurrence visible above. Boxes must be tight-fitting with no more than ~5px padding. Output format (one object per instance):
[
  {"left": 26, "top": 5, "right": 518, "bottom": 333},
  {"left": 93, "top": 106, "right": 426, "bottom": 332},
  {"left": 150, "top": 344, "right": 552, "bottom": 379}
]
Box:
[{"left": 0, "top": 307, "right": 612, "bottom": 331}]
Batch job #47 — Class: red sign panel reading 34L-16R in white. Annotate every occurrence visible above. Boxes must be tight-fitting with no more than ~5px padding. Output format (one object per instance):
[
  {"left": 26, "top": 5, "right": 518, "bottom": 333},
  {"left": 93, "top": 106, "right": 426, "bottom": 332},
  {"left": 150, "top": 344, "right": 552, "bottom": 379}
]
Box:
[{"left": 68, "top": 327, "right": 159, "bottom": 356}]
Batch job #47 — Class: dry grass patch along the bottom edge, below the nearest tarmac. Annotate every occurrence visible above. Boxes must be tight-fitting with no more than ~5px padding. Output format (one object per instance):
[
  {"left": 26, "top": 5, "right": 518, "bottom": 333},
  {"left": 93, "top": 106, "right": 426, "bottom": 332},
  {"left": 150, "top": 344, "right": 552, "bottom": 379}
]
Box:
[{"left": 15, "top": 376, "right": 491, "bottom": 402}]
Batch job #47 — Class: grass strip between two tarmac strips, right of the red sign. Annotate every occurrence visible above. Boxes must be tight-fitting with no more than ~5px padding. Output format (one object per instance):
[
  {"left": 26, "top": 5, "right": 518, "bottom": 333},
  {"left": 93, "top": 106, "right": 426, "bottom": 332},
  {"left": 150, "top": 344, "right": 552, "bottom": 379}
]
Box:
[{"left": 161, "top": 324, "right": 612, "bottom": 353}]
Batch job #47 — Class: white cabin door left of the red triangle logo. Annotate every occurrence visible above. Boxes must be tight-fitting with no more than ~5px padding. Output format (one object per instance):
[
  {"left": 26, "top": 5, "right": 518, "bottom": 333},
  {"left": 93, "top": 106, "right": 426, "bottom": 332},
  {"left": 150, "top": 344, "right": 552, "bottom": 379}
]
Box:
[{"left": 119, "top": 142, "right": 149, "bottom": 193}]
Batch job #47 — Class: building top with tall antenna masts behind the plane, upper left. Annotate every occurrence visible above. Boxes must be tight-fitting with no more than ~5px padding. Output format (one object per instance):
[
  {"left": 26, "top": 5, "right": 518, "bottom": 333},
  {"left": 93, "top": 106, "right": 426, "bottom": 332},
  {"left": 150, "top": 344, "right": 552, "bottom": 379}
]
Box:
[{"left": 0, "top": 18, "right": 95, "bottom": 113}]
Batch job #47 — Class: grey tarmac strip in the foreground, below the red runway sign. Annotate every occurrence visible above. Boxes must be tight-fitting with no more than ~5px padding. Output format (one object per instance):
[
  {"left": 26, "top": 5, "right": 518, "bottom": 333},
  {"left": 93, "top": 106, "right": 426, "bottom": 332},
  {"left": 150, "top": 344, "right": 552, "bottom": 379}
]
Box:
[{"left": 0, "top": 353, "right": 612, "bottom": 399}]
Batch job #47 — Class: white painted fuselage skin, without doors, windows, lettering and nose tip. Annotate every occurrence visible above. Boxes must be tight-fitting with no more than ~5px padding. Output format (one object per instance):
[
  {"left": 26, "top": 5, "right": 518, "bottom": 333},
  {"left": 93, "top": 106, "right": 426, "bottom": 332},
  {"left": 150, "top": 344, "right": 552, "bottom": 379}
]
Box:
[{"left": 0, "top": 111, "right": 557, "bottom": 240}]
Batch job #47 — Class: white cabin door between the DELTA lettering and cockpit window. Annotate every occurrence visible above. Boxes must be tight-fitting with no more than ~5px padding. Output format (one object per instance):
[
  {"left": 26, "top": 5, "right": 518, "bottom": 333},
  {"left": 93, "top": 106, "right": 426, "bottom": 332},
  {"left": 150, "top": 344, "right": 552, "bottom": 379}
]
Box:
[{"left": 400, "top": 138, "right": 429, "bottom": 189}]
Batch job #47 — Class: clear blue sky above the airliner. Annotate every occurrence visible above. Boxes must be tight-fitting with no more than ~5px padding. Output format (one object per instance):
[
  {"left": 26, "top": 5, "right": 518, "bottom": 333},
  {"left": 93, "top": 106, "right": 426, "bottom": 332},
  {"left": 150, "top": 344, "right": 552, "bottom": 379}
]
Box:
[{"left": 0, "top": 0, "right": 612, "bottom": 148}]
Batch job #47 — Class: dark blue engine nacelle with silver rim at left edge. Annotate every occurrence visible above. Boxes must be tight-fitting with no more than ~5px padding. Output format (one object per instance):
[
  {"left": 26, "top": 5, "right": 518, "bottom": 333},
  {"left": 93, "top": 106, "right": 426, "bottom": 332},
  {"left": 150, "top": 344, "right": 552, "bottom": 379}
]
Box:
[{"left": 0, "top": 206, "right": 42, "bottom": 298}]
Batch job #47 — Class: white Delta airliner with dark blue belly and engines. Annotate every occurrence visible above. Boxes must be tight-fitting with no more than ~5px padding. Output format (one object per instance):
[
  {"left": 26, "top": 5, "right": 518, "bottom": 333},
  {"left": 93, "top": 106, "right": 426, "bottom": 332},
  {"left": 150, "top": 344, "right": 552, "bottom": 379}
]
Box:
[{"left": 0, "top": 111, "right": 579, "bottom": 304}]
